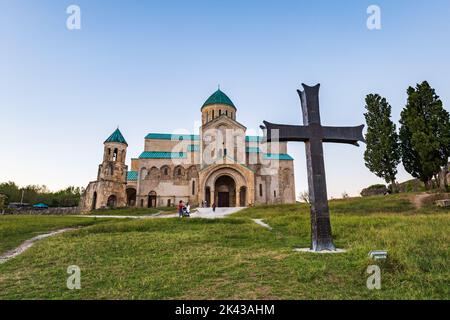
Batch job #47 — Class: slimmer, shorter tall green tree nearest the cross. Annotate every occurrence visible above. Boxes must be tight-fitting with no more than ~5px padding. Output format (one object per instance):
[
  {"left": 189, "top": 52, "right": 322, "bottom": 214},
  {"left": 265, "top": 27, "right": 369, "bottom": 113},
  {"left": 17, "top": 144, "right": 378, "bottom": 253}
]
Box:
[{"left": 364, "top": 94, "right": 401, "bottom": 191}]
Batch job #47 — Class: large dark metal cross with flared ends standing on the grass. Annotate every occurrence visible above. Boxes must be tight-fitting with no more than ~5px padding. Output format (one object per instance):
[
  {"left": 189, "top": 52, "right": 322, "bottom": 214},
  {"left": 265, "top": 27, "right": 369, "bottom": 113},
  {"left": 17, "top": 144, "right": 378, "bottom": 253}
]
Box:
[{"left": 261, "top": 84, "right": 365, "bottom": 251}]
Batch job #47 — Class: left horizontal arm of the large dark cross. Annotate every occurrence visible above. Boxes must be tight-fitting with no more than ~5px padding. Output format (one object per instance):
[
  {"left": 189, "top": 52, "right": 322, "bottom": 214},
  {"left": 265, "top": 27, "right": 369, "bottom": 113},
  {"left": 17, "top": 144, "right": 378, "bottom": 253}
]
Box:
[{"left": 261, "top": 121, "right": 310, "bottom": 142}]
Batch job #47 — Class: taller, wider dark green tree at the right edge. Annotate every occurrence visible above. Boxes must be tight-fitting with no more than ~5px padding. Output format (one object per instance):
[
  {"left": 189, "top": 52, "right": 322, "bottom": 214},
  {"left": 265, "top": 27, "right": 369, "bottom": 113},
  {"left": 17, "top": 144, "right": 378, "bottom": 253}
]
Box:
[{"left": 400, "top": 81, "right": 450, "bottom": 189}]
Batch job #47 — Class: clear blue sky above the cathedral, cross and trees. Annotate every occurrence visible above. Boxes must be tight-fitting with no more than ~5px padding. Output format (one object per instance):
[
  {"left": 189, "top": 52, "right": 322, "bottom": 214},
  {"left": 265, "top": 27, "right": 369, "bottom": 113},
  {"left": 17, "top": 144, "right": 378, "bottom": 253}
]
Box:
[{"left": 0, "top": 0, "right": 450, "bottom": 197}]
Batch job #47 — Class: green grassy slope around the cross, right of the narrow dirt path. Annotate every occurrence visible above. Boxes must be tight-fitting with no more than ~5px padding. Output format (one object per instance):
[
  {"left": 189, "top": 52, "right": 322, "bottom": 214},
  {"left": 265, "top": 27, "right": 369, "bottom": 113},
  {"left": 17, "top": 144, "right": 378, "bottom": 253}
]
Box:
[{"left": 0, "top": 195, "right": 450, "bottom": 299}]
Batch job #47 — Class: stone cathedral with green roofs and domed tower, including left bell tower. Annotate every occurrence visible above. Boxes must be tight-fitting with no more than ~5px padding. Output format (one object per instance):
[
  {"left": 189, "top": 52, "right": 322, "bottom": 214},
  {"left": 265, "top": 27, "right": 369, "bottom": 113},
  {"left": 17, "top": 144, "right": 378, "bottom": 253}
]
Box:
[{"left": 81, "top": 89, "right": 295, "bottom": 212}]
